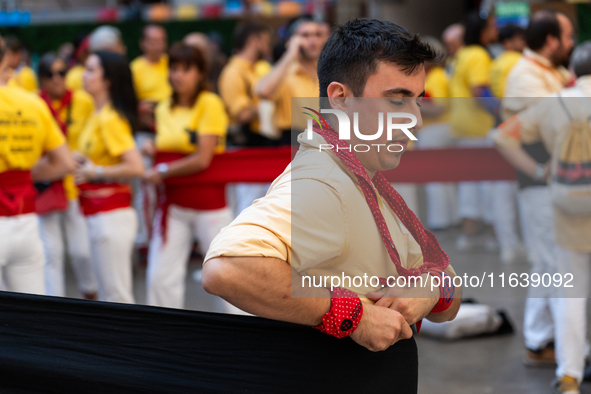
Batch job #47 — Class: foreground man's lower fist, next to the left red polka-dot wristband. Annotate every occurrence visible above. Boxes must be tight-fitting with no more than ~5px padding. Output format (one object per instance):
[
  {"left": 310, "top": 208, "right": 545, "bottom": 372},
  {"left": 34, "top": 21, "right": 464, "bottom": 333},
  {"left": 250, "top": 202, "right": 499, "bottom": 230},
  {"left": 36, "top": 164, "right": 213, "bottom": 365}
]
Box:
[{"left": 350, "top": 303, "right": 412, "bottom": 352}]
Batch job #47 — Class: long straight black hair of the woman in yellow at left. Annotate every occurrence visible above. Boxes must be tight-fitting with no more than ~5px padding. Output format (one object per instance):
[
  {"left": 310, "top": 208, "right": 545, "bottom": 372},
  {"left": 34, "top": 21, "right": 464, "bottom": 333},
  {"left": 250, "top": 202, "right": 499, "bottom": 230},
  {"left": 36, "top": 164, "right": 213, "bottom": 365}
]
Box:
[{"left": 94, "top": 51, "right": 139, "bottom": 132}]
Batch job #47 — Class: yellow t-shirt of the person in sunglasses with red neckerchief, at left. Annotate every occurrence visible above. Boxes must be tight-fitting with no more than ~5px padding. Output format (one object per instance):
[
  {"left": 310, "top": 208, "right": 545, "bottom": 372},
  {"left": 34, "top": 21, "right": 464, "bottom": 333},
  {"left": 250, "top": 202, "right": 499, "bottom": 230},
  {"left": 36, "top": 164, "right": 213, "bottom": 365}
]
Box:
[{"left": 51, "top": 90, "right": 94, "bottom": 200}]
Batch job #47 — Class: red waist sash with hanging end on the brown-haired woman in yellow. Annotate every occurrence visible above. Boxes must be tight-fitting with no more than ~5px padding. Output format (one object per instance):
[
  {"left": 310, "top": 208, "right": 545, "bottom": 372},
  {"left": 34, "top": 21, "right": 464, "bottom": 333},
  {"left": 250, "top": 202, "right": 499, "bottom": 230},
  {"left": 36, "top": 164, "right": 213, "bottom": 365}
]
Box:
[{"left": 154, "top": 151, "right": 226, "bottom": 243}]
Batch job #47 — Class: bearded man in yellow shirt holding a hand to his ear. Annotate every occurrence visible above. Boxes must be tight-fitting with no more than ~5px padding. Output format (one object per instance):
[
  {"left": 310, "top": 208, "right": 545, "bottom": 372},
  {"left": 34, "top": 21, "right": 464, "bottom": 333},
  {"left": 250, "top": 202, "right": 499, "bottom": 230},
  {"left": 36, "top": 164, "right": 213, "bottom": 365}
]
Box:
[{"left": 255, "top": 17, "right": 324, "bottom": 145}]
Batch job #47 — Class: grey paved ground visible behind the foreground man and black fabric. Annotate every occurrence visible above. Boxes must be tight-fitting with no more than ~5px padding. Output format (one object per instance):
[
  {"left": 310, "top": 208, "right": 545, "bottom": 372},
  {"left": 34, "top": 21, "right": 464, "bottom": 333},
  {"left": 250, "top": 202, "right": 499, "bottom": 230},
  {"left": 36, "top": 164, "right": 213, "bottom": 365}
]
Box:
[{"left": 61, "top": 229, "right": 591, "bottom": 394}]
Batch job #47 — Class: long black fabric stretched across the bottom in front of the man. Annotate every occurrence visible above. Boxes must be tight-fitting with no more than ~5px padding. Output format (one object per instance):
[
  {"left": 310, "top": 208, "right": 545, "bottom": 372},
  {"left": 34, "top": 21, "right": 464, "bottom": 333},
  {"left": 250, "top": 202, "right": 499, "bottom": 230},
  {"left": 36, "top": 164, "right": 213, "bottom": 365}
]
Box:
[{"left": 0, "top": 292, "right": 418, "bottom": 394}]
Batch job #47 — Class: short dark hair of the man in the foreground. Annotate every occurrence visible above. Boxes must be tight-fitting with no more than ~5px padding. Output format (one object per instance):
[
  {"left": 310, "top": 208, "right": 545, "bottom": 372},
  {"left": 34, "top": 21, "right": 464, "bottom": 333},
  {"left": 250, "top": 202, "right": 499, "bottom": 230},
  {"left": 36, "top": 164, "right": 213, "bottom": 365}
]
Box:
[{"left": 317, "top": 19, "right": 437, "bottom": 97}]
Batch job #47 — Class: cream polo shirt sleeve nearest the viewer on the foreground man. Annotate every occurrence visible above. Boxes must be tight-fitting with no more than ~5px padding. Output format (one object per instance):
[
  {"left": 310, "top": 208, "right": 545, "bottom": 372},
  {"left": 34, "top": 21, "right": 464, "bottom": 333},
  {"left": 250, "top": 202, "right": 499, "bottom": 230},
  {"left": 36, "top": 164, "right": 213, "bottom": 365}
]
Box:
[{"left": 205, "top": 179, "right": 347, "bottom": 272}]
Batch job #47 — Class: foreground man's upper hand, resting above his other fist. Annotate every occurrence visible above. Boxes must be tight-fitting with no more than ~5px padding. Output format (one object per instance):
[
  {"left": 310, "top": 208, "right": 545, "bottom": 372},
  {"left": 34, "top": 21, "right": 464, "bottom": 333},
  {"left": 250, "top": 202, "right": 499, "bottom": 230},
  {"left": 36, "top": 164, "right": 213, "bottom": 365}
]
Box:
[{"left": 367, "top": 274, "right": 440, "bottom": 324}]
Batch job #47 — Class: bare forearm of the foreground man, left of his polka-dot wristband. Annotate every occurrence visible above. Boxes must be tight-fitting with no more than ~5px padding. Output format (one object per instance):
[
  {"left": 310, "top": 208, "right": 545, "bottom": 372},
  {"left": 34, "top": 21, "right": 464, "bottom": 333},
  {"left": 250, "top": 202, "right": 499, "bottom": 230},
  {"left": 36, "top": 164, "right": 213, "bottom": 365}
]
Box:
[{"left": 203, "top": 257, "right": 330, "bottom": 326}]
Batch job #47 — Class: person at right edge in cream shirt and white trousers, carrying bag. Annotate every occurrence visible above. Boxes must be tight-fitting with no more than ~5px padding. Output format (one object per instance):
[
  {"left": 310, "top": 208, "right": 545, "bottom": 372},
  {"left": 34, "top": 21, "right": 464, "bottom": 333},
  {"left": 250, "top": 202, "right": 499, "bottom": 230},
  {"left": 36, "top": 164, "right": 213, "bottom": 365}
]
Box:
[{"left": 496, "top": 42, "right": 591, "bottom": 394}]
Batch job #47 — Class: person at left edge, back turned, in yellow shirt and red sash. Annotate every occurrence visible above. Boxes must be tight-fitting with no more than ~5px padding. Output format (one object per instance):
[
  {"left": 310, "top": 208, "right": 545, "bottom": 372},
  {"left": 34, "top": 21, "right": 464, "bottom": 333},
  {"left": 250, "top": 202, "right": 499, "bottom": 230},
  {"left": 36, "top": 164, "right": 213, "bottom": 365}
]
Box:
[{"left": 0, "top": 37, "right": 74, "bottom": 294}]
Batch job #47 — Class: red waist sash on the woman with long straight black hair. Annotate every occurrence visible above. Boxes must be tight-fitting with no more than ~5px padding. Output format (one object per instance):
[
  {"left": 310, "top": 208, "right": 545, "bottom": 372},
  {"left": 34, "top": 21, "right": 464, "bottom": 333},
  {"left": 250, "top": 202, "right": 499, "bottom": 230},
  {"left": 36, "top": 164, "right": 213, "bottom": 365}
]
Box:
[{"left": 78, "top": 183, "right": 131, "bottom": 216}]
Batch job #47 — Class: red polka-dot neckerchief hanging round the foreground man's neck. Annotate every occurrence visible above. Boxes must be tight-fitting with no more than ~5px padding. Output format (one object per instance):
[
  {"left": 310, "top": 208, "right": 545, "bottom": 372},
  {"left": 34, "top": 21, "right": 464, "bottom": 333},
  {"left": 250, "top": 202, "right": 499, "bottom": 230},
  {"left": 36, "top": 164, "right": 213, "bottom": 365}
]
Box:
[{"left": 314, "top": 123, "right": 449, "bottom": 277}]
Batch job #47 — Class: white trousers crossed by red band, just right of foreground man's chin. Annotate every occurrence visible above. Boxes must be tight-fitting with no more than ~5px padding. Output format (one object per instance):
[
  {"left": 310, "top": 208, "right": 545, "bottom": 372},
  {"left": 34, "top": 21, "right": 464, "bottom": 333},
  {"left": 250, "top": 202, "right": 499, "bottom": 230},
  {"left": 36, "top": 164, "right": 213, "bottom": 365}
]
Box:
[{"left": 417, "top": 123, "right": 460, "bottom": 229}]
